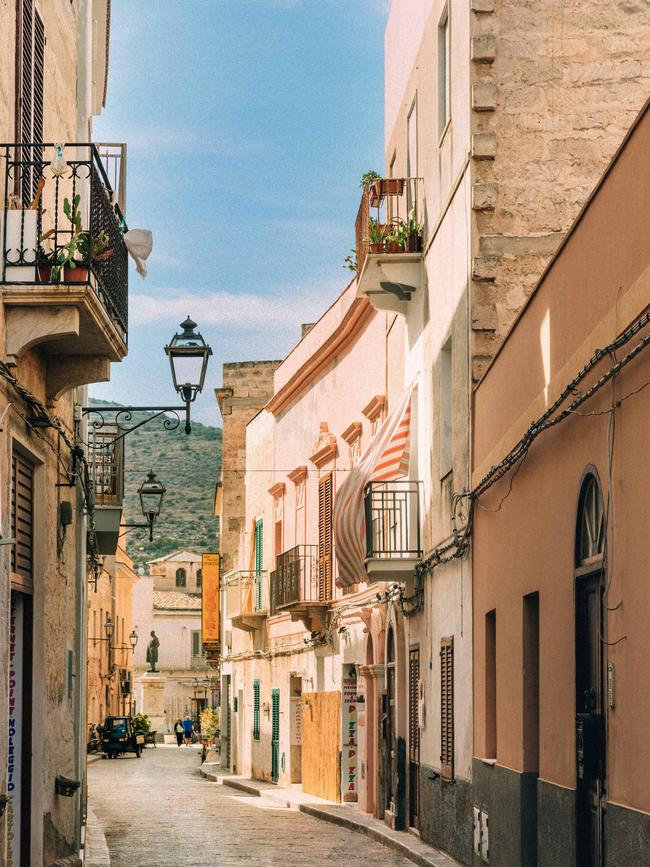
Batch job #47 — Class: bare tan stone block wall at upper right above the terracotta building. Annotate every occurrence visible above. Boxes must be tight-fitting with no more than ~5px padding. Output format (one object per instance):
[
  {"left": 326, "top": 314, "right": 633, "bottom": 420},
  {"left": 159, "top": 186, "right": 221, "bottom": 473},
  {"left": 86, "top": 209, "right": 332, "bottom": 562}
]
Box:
[{"left": 470, "top": 0, "right": 650, "bottom": 382}]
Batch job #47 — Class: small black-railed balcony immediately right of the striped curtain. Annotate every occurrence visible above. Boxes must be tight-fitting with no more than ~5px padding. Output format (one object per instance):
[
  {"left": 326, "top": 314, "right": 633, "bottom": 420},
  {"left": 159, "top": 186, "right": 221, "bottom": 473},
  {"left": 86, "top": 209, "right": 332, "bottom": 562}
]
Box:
[{"left": 365, "top": 481, "right": 422, "bottom": 583}]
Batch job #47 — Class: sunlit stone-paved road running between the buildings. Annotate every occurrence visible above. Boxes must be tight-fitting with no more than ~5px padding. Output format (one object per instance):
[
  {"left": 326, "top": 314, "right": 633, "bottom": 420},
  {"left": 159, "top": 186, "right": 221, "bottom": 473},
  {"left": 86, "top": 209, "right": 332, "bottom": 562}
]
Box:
[{"left": 88, "top": 748, "right": 412, "bottom": 867}]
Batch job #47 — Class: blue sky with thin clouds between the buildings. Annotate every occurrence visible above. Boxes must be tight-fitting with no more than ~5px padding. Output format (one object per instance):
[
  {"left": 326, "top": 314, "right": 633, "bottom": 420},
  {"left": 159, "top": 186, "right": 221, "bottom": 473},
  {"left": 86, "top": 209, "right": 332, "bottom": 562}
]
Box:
[{"left": 91, "top": 0, "right": 388, "bottom": 424}]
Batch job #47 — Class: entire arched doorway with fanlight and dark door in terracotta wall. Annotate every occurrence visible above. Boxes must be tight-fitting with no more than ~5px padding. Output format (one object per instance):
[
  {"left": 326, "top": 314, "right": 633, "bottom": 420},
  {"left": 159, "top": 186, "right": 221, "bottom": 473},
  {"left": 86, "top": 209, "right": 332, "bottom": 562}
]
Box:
[{"left": 574, "top": 472, "right": 607, "bottom": 867}]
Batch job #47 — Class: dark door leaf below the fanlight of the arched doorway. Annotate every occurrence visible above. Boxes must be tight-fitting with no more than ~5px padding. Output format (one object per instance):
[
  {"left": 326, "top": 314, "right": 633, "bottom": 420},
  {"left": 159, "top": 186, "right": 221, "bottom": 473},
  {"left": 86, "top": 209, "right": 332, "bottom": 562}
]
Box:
[{"left": 575, "top": 571, "right": 607, "bottom": 867}]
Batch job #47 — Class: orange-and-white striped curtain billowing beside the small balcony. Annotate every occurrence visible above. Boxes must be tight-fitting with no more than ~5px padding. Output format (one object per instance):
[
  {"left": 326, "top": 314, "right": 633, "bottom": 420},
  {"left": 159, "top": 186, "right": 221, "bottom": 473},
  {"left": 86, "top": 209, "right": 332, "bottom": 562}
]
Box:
[{"left": 334, "top": 383, "right": 415, "bottom": 587}]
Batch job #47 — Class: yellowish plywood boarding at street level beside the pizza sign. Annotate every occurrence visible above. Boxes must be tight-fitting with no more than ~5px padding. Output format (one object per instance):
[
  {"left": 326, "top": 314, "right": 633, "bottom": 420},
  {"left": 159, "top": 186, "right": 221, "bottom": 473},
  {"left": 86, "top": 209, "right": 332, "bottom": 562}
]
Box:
[{"left": 302, "top": 692, "right": 341, "bottom": 801}]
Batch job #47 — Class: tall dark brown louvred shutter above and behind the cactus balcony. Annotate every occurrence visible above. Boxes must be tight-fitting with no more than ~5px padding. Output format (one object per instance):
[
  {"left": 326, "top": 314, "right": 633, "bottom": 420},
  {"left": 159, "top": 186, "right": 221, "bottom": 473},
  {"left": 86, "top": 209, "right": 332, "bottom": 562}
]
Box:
[{"left": 16, "top": 0, "right": 45, "bottom": 207}]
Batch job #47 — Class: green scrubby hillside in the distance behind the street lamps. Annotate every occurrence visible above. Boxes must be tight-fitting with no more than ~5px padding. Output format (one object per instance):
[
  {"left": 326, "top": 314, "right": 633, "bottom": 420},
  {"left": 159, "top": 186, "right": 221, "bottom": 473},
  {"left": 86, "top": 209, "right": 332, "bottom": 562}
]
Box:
[{"left": 90, "top": 399, "right": 221, "bottom": 569}]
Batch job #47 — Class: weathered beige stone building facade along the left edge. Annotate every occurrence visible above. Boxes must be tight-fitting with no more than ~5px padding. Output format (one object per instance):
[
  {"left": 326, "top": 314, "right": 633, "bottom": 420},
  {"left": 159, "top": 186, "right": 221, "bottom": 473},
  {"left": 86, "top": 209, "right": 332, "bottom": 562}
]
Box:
[{"left": 0, "top": 0, "right": 127, "bottom": 865}]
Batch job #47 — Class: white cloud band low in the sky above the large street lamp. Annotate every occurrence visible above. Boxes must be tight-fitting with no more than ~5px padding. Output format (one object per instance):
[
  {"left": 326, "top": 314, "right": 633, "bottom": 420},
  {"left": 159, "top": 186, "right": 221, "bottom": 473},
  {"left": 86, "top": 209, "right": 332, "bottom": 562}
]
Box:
[{"left": 129, "top": 278, "right": 345, "bottom": 331}]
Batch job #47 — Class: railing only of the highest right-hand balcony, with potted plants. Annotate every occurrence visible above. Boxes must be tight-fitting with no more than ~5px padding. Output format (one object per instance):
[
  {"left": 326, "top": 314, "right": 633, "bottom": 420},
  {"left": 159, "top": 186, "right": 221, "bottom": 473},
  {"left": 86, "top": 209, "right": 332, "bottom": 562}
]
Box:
[{"left": 355, "top": 178, "right": 425, "bottom": 274}]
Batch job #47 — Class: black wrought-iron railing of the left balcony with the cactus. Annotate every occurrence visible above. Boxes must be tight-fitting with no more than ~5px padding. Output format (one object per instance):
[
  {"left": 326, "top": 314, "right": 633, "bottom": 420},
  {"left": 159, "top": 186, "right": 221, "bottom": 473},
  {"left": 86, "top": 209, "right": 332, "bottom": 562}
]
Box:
[{"left": 0, "top": 143, "right": 128, "bottom": 341}]
